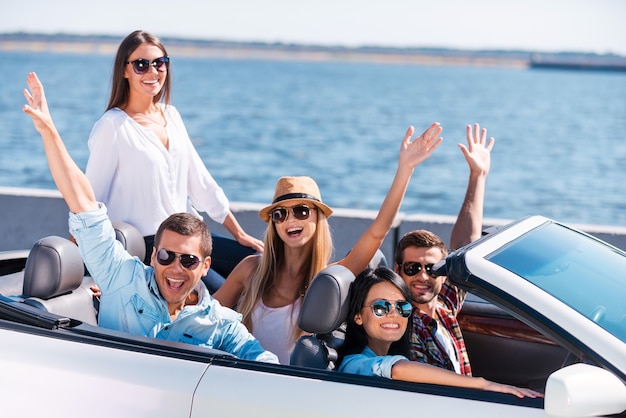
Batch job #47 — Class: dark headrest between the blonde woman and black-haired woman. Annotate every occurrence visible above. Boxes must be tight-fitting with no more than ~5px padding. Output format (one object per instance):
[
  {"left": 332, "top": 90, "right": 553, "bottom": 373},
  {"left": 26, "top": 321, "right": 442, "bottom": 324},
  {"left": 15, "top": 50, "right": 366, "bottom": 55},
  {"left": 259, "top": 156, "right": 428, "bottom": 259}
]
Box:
[{"left": 298, "top": 264, "right": 354, "bottom": 333}]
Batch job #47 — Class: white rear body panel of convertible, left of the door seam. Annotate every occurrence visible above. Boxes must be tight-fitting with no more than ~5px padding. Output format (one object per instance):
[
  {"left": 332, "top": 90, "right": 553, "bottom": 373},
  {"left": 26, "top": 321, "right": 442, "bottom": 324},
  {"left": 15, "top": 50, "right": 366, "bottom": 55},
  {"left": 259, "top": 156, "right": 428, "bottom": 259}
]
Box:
[{"left": 0, "top": 321, "right": 207, "bottom": 418}]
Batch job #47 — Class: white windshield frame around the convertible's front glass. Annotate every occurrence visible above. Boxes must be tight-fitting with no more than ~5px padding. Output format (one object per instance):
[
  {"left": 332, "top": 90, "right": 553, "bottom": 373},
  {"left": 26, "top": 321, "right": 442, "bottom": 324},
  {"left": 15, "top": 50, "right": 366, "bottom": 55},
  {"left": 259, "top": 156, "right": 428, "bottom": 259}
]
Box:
[{"left": 446, "top": 216, "right": 626, "bottom": 381}]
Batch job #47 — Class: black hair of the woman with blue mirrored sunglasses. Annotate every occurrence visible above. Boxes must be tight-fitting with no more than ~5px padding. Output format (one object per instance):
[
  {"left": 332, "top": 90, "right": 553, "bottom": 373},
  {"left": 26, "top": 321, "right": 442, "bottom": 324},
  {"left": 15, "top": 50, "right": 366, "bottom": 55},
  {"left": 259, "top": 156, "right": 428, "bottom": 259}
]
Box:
[{"left": 337, "top": 267, "right": 411, "bottom": 364}]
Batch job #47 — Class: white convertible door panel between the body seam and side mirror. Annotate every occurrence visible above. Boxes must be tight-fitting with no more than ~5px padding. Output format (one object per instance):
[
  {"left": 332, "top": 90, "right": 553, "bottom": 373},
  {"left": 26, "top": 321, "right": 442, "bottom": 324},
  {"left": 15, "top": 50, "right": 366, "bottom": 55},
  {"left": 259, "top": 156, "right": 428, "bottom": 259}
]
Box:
[{"left": 191, "top": 359, "right": 545, "bottom": 418}]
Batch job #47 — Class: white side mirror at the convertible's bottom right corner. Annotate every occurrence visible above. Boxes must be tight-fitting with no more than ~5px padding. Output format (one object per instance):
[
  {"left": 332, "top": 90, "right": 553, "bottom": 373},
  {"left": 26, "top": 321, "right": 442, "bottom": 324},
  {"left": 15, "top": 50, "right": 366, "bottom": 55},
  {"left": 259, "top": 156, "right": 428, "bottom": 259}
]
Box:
[{"left": 544, "top": 363, "right": 626, "bottom": 417}]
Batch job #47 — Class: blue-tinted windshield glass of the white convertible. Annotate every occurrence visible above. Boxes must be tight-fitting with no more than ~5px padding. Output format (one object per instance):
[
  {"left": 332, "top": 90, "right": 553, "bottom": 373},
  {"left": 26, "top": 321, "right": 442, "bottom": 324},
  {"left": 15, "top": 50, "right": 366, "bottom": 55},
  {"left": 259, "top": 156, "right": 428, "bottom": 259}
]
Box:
[{"left": 486, "top": 222, "right": 626, "bottom": 342}]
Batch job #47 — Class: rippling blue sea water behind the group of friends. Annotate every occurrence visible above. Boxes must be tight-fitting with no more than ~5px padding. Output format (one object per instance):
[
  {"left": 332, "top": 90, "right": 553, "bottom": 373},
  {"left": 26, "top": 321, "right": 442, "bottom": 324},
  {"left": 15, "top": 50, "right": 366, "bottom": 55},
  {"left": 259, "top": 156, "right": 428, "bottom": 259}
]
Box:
[{"left": 0, "top": 52, "right": 626, "bottom": 226}]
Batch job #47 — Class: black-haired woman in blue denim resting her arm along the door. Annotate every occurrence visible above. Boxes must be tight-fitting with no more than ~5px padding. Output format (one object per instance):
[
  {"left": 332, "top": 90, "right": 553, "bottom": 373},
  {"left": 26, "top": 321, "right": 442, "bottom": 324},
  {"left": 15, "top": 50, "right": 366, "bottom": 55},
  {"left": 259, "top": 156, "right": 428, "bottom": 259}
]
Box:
[{"left": 339, "top": 267, "right": 542, "bottom": 398}]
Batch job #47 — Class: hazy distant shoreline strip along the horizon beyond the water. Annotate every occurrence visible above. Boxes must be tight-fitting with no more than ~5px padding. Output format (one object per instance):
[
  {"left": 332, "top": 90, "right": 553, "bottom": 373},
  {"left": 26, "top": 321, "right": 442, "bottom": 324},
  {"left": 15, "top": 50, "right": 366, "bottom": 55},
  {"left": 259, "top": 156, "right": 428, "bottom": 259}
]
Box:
[{"left": 0, "top": 33, "right": 626, "bottom": 71}]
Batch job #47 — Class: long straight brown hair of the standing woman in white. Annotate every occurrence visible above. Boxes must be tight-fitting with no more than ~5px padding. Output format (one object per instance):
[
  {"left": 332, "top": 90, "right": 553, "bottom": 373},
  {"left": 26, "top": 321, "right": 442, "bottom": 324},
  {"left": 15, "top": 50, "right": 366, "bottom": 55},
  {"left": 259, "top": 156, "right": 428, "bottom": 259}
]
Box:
[{"left": 107, "top": 30, "right": 171, "bottom": 110}]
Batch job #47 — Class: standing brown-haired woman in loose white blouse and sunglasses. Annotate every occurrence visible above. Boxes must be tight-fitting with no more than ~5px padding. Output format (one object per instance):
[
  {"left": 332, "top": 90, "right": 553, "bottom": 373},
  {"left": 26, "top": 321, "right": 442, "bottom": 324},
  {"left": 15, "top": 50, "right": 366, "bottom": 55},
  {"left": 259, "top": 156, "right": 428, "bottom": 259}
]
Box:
[{"left": 86, "top": 31, "right": 263, "bottom": 290}]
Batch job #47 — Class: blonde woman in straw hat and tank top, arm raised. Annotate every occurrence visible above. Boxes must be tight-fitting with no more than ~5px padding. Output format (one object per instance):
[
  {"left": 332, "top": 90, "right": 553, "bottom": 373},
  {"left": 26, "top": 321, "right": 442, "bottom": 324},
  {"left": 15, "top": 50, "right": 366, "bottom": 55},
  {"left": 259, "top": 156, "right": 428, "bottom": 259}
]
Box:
[{"left": 214, "top": 123, "right": 442, "bottom": 364}]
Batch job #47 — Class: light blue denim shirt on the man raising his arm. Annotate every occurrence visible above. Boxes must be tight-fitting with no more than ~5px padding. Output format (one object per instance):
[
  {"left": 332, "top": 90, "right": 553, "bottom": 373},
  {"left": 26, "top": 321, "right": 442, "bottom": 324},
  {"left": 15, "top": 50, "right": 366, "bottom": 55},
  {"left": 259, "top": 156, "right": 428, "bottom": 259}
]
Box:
[{"left": 69, "top": 203, "right": 278, "bottom": 363}]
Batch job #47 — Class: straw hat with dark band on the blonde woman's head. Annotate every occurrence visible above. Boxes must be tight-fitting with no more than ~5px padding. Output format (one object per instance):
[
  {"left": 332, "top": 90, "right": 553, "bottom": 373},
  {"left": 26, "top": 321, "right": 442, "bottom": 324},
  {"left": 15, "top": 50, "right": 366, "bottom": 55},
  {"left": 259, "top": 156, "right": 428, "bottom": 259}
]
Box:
[{"left": 259, "top": 176, "right": 333, "bottom": 222}]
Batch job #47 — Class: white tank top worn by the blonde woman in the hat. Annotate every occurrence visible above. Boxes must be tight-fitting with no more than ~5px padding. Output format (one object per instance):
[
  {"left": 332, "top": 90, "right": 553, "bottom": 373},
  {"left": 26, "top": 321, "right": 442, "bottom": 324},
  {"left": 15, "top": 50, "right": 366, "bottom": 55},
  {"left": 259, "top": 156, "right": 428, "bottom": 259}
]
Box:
[{"left": 252, "top": 298, "right": 302, "bottom": 364}]
